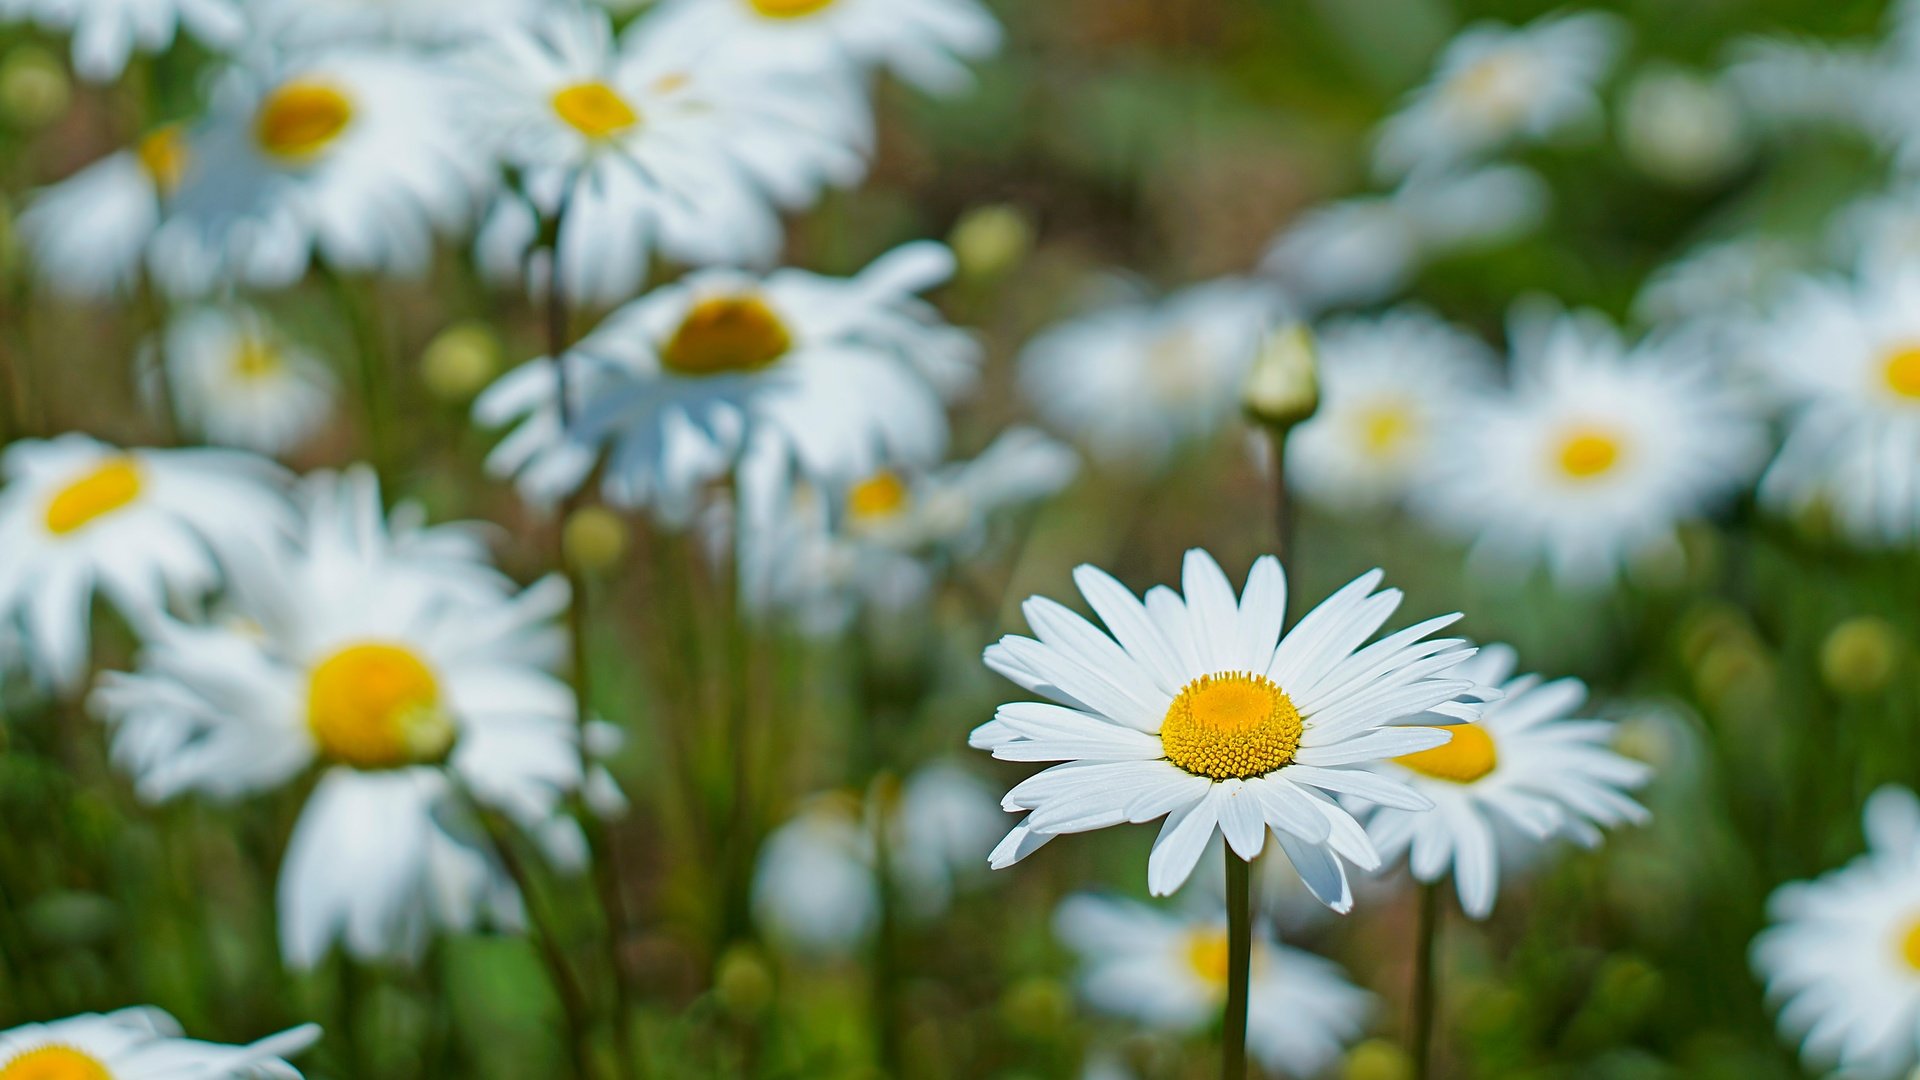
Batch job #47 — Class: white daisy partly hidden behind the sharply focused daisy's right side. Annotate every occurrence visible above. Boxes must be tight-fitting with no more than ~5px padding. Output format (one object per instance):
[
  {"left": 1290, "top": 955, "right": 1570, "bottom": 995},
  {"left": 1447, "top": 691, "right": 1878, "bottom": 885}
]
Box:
[{"left": 1367, "top": 646, "right": 1653, "bottom": 919}]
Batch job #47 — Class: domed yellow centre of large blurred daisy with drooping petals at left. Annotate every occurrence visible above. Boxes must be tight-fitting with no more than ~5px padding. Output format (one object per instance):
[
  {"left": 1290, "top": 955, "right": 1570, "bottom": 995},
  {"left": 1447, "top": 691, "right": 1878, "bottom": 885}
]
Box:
[{"left": 307, "top": 642, "right": 457, "bottom": 769}]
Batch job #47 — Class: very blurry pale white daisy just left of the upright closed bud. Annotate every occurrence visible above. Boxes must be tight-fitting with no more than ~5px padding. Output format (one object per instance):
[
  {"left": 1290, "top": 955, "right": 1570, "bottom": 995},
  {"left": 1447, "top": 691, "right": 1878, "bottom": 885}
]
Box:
[{"left": 1020, "top": 279, "right": 1284, "bottom": 467}]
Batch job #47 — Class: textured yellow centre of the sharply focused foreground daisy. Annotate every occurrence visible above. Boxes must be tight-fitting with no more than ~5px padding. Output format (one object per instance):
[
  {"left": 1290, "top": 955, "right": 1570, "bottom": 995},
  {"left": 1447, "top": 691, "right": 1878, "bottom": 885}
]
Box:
[{"left": 1160, "top": 671, "right": 1302, "bottom": 780}]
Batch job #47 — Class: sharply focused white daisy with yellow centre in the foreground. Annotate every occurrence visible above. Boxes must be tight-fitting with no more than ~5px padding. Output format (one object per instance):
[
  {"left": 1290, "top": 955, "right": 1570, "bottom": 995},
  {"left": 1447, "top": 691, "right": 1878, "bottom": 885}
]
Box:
[{"left": 970, "top": 550, "right": 1476, "bottom": 899}]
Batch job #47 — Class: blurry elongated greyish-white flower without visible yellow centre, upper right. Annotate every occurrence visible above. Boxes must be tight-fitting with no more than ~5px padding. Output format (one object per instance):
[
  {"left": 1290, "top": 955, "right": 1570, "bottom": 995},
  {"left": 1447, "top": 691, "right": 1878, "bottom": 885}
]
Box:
[{"left": 1261, "top": 165, "right": 1548, "bottom": 311}]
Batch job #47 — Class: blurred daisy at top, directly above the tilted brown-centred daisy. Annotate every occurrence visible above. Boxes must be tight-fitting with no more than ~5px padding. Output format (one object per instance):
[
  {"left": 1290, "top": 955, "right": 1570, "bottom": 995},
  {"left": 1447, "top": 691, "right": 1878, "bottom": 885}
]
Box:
[{"left": 468, "top": 6, "right": 872, "bottom": 306}]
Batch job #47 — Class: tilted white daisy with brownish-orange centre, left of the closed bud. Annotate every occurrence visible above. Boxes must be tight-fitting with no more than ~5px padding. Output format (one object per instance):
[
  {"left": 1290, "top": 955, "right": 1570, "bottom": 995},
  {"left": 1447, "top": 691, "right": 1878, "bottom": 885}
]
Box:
[{"left": 474, "top": 242, "right": 979, "bottom": 521}]
